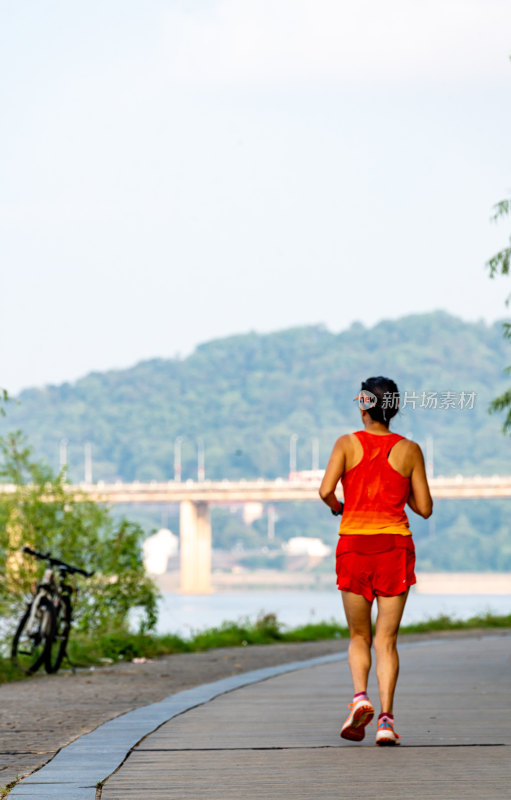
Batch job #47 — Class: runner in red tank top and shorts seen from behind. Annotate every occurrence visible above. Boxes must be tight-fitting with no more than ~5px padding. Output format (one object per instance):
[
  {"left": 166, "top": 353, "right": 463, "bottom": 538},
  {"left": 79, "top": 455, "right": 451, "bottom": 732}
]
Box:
[{"left": 319, "top": 376, "right": 433, "bottom": 745}]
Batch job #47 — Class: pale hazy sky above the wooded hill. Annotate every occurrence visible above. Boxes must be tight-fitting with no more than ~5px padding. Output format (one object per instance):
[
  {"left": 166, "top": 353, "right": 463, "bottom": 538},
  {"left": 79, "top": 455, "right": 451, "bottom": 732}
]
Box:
[{"left": 0, "top": 0, "right": 511, "bottom": 392}]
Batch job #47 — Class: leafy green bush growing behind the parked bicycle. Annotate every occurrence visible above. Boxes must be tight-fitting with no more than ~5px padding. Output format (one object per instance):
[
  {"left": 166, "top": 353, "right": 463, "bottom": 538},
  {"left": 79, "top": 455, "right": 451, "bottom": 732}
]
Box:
[{"left": 0, "top": 432, "right": 157, "bottom": 632}]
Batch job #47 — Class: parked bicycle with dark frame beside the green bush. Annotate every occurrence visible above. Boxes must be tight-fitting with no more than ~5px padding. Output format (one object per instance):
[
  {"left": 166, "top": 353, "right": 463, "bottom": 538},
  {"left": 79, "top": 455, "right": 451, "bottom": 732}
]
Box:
[{"left": 11, "top": 547, "right": 94, "bottom": 675}]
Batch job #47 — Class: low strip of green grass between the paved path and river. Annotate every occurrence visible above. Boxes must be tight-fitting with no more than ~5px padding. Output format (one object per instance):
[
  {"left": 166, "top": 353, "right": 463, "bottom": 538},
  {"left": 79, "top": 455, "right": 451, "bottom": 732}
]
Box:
[{"left": 0, "top": 614, "right": 511, "bottom": 683}]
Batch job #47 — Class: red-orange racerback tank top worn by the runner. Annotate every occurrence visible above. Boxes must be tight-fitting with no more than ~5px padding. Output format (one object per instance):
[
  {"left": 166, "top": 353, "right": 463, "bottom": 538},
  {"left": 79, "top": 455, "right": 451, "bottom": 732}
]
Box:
[{"left": 339, "top": 431, "right": 411, "bottom": 536}]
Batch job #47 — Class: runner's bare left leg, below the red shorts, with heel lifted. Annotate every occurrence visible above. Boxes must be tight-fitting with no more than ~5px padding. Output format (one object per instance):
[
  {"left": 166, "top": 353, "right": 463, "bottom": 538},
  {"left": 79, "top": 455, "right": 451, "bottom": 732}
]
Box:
[{"left": 342, "top": 592, "right": 372, "bottom": 694}]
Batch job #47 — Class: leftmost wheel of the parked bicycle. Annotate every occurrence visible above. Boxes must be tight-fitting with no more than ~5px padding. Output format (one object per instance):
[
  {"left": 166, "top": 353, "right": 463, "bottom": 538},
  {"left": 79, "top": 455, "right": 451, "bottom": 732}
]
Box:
[{"left": 11, "top": 597, "right": 54, "bottom": 674}]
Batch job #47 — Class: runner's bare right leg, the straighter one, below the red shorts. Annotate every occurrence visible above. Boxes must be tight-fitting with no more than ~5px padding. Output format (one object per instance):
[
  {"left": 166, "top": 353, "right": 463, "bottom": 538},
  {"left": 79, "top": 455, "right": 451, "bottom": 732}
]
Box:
[{"left": 374, "top": 591, "right": 408, "bottom": 714}]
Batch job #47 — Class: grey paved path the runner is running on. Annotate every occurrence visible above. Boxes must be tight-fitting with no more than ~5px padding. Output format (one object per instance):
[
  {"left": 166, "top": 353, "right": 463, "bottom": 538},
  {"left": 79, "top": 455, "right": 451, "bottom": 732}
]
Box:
[{"left": 12, "top": 635, "right": 511, "bottom": 800}]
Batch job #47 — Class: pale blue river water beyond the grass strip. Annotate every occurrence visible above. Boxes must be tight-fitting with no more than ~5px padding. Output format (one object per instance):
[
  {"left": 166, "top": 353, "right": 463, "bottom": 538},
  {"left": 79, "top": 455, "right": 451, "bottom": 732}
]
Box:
[{"left": 157, "top": 589, "right": 511, "bottom": 636}]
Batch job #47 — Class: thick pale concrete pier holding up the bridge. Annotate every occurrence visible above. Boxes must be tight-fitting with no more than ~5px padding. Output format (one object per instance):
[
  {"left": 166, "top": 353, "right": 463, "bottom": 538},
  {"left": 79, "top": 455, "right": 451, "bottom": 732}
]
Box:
[{"left": 179, "top": 500, "right": 211, "bottom": 594}]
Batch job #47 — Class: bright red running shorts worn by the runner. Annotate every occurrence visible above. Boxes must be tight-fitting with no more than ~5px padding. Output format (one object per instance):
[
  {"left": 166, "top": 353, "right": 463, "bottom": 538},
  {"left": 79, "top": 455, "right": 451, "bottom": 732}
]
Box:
[{"left": 336, "top": 533, "right": 417, "bottom": 603}]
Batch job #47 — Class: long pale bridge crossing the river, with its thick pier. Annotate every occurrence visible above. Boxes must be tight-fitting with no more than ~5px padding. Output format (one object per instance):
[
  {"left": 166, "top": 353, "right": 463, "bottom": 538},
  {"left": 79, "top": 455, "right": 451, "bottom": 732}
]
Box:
[{"left": 4, "top": 472, "right": 511, "bottom": 594}]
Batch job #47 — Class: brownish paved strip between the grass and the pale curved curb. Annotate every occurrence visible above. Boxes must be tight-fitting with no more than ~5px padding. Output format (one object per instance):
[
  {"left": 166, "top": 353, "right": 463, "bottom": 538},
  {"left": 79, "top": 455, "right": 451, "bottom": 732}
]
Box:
[{"left": 0, "top": 636, "right": 344, "bottom": 792}]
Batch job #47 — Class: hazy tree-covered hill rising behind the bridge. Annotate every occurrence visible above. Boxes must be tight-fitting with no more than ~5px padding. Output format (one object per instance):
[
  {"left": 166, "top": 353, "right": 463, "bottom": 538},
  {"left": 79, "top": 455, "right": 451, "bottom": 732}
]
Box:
[{"left": 0, "top": 311, "right": 511, "bottom": 481}]
